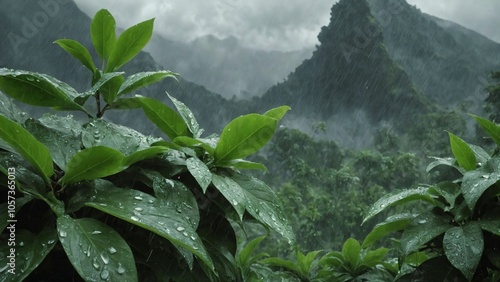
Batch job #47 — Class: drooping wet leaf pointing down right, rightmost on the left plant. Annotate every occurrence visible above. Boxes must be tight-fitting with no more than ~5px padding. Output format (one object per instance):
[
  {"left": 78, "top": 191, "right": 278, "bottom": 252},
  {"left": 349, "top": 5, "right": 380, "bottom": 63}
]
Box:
[{"left": 231, "top": 173, "right": 295, "bottom": 244}]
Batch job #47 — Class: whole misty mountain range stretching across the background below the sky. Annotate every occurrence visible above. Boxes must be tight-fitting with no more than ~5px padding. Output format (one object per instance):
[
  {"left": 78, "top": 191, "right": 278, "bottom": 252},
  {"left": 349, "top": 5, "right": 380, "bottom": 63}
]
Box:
[{"left": 0, "top": 0, "right": 500, "bottom": 147}]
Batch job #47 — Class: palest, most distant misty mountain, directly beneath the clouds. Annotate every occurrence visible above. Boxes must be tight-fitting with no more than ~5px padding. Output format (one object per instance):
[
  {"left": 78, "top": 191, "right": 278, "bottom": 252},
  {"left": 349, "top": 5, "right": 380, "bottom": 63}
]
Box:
[{"left": 146, "top": 34, "right": 312, "bottom": 99}]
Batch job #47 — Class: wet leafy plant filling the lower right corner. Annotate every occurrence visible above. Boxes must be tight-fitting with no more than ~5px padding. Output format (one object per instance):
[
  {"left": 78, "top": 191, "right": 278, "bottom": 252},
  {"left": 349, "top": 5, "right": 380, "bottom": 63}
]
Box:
[{"left": 364, "top": 116, "right": 500, "bottom": 281}]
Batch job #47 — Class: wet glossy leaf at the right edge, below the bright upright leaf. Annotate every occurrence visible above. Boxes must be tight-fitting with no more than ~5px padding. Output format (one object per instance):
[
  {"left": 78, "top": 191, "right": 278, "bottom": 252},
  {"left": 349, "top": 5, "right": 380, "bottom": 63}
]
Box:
[{"left": 461, "top": 158, "right": 500, "bottom": 211}]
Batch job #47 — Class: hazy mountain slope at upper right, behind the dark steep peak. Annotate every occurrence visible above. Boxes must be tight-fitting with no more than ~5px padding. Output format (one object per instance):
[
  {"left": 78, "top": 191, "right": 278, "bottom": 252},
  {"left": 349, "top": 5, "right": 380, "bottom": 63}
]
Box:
[{"left": 369, "top": 0, "right": 500, "bottom": 108}]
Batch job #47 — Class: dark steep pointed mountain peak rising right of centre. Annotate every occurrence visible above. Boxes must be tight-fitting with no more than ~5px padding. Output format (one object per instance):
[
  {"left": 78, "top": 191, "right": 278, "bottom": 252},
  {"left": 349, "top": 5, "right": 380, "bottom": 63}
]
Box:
[{"left": 261, "top": 0, "right": 432, "bottom": 131}]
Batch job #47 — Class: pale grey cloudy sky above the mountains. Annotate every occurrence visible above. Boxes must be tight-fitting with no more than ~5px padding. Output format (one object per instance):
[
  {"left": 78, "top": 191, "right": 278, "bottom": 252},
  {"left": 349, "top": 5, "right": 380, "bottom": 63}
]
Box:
[{"left": 75, "top": 0, "right": 500, "bottom": 51}]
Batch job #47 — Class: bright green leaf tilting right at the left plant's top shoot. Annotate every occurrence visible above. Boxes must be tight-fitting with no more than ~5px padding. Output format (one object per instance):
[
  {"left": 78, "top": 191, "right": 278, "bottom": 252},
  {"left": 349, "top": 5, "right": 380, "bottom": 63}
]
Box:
[{"left": 106, "top": 19, "right": 154, "bottom": 72}]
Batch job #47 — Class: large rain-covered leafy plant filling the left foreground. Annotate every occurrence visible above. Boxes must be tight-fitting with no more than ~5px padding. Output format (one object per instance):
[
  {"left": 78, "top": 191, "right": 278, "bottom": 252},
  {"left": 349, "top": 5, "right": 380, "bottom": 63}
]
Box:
[{"left": 0, "top": 10, "right": 295, "bottom": 281}]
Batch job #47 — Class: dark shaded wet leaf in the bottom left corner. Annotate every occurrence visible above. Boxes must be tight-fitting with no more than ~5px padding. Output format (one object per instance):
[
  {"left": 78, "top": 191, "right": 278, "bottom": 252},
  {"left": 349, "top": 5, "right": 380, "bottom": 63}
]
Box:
[{"left": 0, "top": 229, "right": 57, "bottom": 281}]
